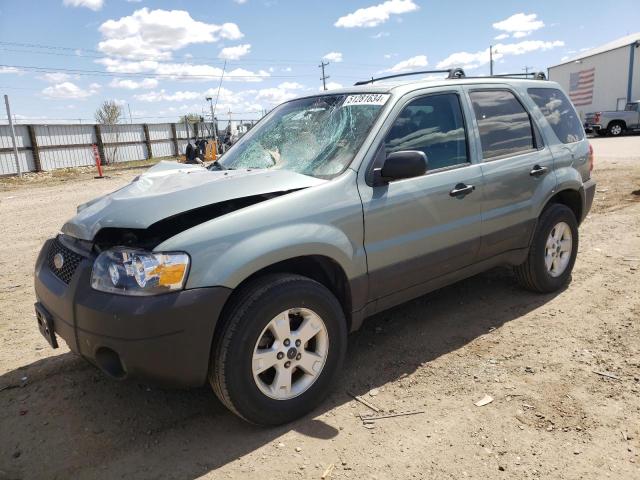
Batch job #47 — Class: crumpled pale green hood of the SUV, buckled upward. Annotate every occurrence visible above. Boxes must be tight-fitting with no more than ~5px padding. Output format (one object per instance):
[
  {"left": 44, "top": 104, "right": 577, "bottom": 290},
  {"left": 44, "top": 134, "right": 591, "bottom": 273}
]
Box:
[{"left": 62, "top": 161, "right": 326, "bottom": 240}]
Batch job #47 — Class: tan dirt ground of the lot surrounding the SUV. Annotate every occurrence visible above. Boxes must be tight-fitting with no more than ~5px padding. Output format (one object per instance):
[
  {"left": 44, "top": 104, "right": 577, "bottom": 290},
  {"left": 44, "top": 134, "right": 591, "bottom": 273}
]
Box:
[{"left": 0, "top": 136, "right": 640, "bottom": 479}]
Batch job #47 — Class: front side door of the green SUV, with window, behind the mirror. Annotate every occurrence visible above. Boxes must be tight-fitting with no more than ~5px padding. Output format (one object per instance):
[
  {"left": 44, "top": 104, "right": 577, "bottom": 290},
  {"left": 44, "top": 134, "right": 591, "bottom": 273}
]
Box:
[{"left": 358, "top": 87, "right": 482, "bottom": 300}]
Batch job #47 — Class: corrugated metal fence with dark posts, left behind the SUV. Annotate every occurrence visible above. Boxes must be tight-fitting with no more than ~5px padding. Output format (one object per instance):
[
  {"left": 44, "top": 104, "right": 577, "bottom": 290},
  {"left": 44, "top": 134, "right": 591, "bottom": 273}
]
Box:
[{"left": 0, "top": 122, "right": 242, "bottom": 175}]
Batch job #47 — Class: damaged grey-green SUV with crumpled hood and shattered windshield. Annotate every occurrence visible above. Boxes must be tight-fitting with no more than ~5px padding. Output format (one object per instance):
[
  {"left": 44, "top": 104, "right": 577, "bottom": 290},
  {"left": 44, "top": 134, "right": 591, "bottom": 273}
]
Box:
[{"left": 35, "top": 70, "right": 595, "bottom": 425}]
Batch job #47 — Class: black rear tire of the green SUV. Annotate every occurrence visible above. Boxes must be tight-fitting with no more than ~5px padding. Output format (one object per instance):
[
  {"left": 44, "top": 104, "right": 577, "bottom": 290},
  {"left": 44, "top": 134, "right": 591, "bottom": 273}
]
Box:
[{"left": 514, "top": 203, "right": 578, "bottom": 293}]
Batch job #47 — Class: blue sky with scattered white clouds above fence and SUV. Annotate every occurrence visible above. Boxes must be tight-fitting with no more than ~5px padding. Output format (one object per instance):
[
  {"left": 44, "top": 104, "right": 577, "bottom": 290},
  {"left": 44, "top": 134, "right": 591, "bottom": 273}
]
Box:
[{"left": 0, "top": 0, "right": 640, "bottom": 123}]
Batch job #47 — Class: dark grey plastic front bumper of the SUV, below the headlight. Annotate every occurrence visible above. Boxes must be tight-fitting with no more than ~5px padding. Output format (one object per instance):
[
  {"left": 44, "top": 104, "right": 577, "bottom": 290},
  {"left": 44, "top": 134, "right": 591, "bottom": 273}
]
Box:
[{"left": 35, "top": 239, "right": 231, "bottom": 387}]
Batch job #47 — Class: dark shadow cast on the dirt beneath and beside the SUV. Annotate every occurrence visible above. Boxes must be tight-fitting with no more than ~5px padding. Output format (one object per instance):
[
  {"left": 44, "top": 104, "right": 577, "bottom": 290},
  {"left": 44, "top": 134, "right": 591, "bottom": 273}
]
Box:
[{"left": 0, "top": 269, "right": 554, "bottom": 479}]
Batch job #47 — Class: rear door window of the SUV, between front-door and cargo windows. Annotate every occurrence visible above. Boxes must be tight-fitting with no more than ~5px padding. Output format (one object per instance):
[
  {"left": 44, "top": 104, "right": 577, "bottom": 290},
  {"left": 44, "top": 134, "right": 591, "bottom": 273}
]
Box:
[{"left": 469, "top": 90, "right": 536, "bottom": 160}]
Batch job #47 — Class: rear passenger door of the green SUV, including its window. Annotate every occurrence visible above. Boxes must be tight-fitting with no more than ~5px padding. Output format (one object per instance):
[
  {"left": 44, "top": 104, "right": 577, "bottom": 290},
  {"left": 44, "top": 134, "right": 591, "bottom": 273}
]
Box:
[{"left": 466, "top": 85, "right": 556, "bottom": 260}]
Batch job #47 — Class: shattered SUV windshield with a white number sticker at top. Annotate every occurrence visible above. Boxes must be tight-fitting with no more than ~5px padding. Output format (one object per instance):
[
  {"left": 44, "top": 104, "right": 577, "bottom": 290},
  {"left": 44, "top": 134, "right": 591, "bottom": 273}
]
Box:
[{"left": 220, "top": 94, "right": 389, "bottom": 178}]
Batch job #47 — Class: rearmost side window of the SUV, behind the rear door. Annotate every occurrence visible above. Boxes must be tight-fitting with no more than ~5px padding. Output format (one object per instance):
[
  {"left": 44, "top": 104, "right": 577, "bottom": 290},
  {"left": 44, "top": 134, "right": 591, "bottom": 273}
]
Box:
[{"left": 527, "top": 88, "right": 584, "bottom": 143}]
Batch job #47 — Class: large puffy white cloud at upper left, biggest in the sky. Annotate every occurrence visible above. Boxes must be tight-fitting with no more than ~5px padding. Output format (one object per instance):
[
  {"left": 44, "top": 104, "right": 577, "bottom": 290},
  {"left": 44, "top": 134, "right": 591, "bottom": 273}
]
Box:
[{"left": 98, "top": 7, "right": 244, "bottom": 60}]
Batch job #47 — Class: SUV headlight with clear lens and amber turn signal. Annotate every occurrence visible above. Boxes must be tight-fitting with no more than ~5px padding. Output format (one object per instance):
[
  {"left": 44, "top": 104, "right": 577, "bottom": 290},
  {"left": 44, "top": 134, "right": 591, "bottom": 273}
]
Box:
[{"left": 91, "top": 248, "right": 189, "bottom": 296}]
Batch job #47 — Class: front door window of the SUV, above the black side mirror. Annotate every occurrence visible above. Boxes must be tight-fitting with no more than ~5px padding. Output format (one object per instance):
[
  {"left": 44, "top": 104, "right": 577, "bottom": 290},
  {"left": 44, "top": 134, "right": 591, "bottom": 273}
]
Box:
[{"left": 384, "top": 93, "right": 469, "bottom": 170}]
